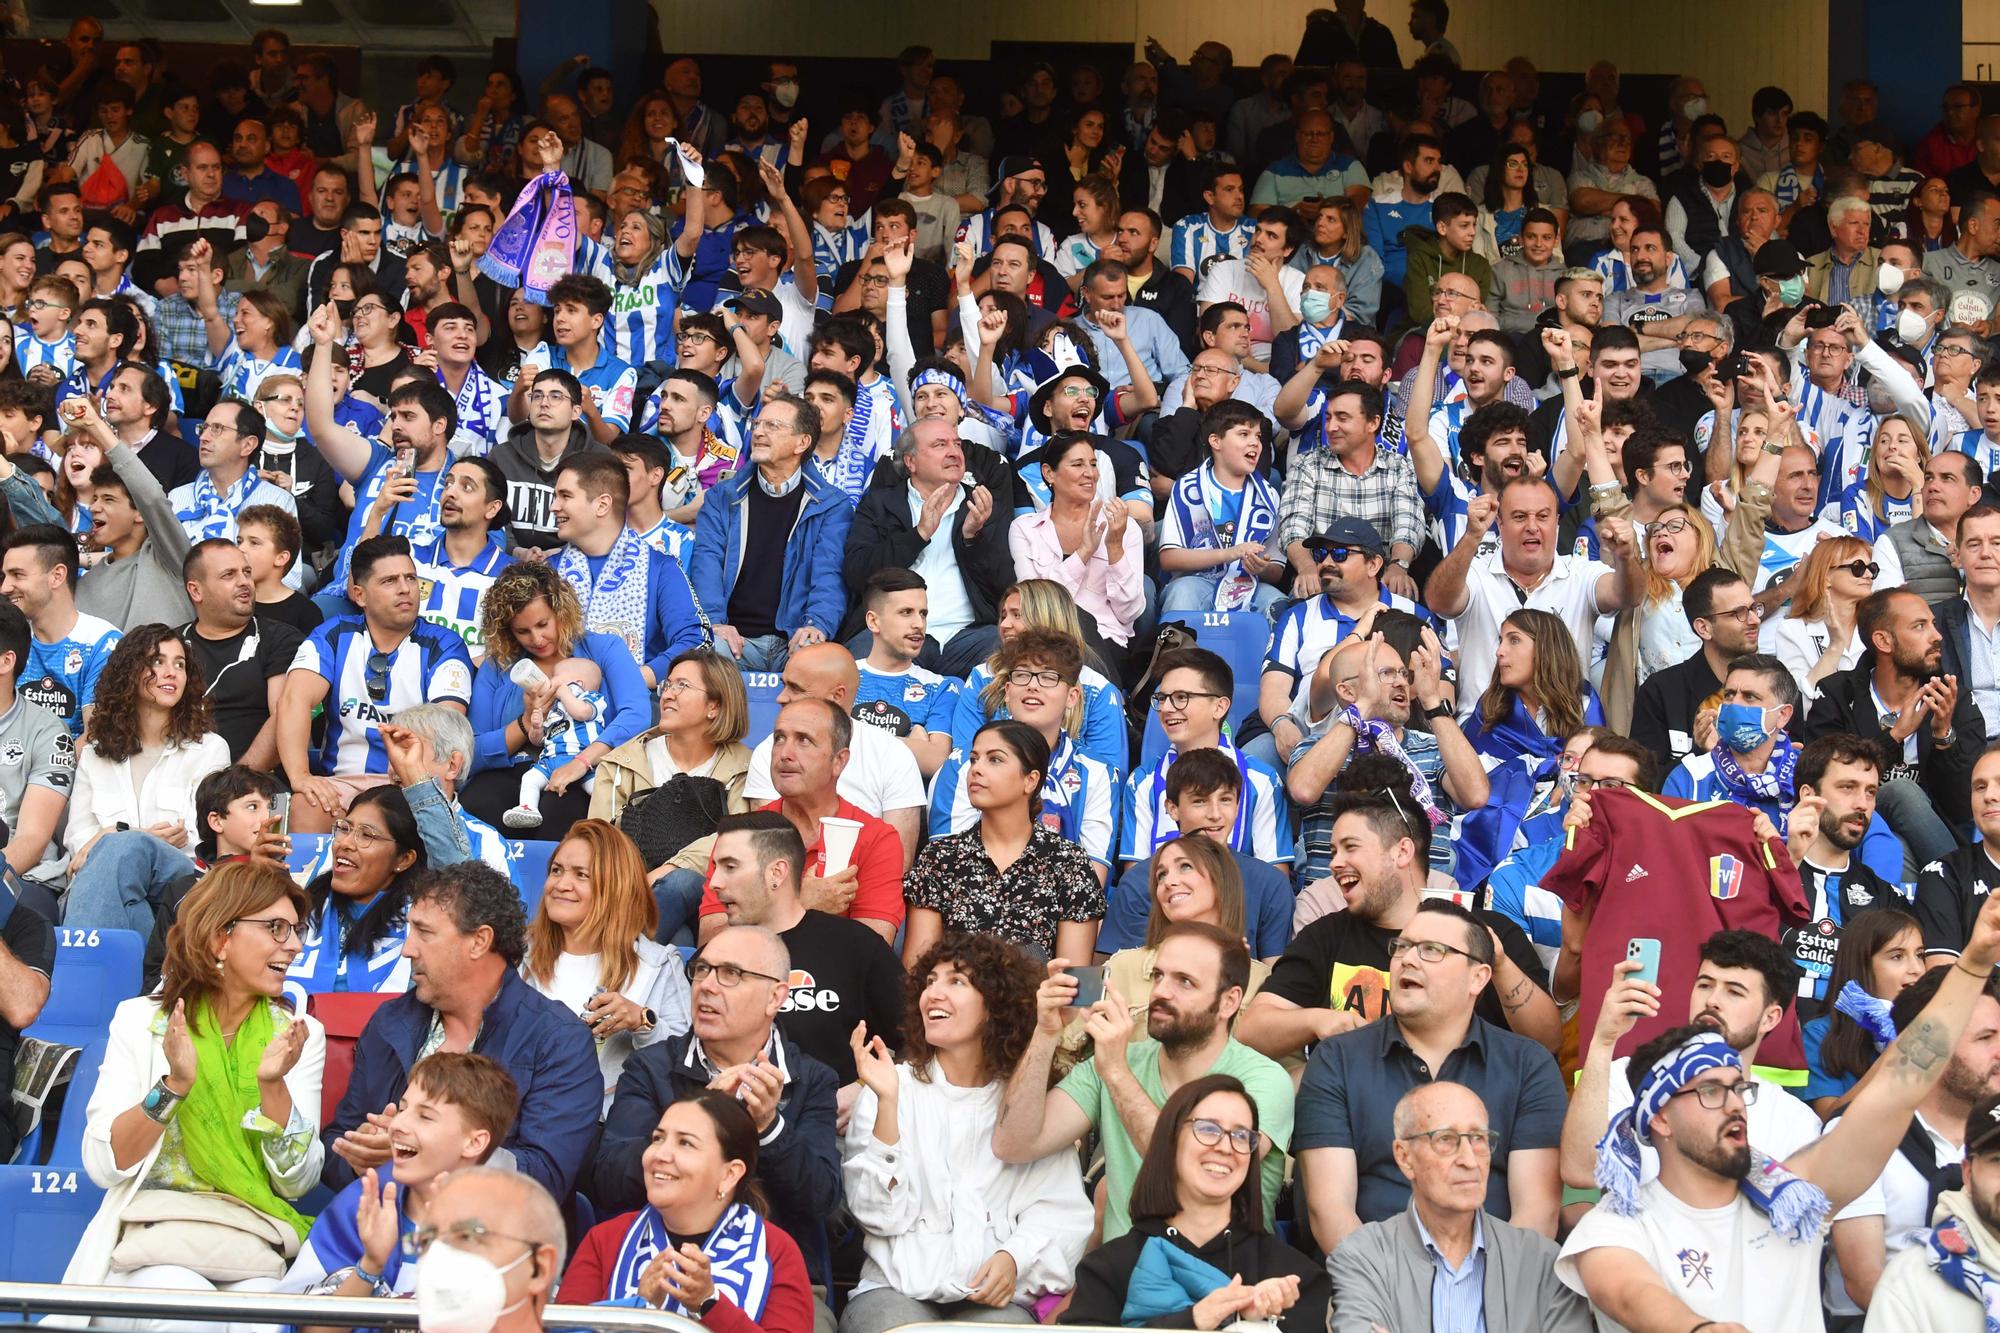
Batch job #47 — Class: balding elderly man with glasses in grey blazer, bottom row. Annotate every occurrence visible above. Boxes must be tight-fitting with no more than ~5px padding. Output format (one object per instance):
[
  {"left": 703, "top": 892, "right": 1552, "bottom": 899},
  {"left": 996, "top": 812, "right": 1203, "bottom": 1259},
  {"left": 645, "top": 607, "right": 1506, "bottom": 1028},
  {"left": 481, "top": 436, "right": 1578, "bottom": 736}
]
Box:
[{"left": 1326, "top": 1083, "right": 1592, "bottom": 1333}]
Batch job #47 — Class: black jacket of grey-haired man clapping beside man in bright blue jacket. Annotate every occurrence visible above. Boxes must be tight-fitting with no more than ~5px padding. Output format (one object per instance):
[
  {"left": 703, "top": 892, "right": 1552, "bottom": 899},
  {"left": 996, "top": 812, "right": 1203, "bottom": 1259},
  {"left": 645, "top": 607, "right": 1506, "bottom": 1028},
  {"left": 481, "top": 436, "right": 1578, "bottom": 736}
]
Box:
[{"left": 840, "top": 444, "right": 1014, "bottom": 640}]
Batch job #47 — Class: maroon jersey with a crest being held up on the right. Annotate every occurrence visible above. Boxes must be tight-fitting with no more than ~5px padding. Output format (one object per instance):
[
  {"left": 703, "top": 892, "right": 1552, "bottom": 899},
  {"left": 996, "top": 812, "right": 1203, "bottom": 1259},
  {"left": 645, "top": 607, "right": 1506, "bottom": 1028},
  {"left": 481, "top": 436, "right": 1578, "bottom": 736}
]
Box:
[{"left": 1542, "top": 789, "right": 1808, "bottom": 1069}]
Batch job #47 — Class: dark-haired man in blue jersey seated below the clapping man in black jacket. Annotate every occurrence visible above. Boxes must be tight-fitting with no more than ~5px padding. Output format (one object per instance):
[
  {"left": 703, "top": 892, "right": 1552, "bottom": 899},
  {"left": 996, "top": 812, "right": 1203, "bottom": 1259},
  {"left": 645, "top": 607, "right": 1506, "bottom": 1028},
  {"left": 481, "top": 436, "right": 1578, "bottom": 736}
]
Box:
[{"left": 852, "top": 568, "right": 964, "bottom": 779}]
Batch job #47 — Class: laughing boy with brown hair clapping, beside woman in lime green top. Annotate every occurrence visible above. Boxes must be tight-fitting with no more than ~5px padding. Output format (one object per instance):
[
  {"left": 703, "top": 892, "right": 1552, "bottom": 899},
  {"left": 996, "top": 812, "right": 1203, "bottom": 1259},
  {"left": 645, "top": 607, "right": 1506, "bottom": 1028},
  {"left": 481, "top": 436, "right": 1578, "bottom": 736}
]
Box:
[{"left": 278, "top": 1051, "right": 520, "bottom": 1297}]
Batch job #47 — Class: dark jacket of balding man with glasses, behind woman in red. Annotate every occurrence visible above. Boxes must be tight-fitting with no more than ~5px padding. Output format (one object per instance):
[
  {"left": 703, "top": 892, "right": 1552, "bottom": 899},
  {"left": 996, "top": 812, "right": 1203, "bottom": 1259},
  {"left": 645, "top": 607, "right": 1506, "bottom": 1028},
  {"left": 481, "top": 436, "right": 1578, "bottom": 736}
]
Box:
[{"left": 584, "top": 1033, "right": 842, "bottom": 1255}]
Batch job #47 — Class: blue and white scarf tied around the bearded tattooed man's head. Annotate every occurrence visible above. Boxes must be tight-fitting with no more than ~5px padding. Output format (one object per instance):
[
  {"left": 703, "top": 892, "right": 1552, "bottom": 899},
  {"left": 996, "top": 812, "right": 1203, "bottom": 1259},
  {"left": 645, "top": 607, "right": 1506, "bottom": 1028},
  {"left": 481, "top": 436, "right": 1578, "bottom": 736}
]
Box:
[{"left": 1596, "top": 1033, "right": 1832, "bottom": 1245}]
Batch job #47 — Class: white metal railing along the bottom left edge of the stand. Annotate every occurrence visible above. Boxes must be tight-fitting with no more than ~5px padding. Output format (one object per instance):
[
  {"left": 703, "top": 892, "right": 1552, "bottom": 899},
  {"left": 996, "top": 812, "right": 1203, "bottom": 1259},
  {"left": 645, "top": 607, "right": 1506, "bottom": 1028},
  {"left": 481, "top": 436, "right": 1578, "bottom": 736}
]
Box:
[{"left": 0, "top": 1283, "right": 704, "bottom": 1333}]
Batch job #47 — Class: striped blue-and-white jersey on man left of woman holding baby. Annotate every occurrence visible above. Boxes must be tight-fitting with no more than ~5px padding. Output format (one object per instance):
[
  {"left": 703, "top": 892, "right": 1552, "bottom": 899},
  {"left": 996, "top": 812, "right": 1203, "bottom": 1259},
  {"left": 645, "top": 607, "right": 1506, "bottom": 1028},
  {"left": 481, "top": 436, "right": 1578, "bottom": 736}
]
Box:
[{"left": 292, "top": 614, "right": 472, "bottom": 777}]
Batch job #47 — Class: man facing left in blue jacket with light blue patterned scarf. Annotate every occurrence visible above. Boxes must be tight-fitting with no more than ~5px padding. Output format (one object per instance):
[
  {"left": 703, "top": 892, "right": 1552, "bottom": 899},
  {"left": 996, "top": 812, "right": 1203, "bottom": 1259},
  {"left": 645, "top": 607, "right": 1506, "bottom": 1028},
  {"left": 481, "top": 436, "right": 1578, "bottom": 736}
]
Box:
[{"left": 550, "top": 450, "right": 708, "bottom": 689}]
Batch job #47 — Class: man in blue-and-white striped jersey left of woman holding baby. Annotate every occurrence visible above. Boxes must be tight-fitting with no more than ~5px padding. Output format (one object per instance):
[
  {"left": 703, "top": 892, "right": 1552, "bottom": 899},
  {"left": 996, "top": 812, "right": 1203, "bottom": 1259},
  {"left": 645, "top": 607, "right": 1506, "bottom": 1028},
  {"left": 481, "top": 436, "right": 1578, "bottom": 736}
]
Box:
[{"left": 278, "top": 532, "right": 472, "bottom": 833}]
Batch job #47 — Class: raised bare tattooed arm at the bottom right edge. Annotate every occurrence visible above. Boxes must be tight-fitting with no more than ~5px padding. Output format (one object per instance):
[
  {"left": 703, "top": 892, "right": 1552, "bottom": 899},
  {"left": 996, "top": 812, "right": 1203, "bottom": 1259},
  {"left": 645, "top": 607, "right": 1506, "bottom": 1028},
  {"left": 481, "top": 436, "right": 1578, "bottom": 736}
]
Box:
[{"left": 1786, "top": 897, "right": 2000, "bottom": 1213}]
